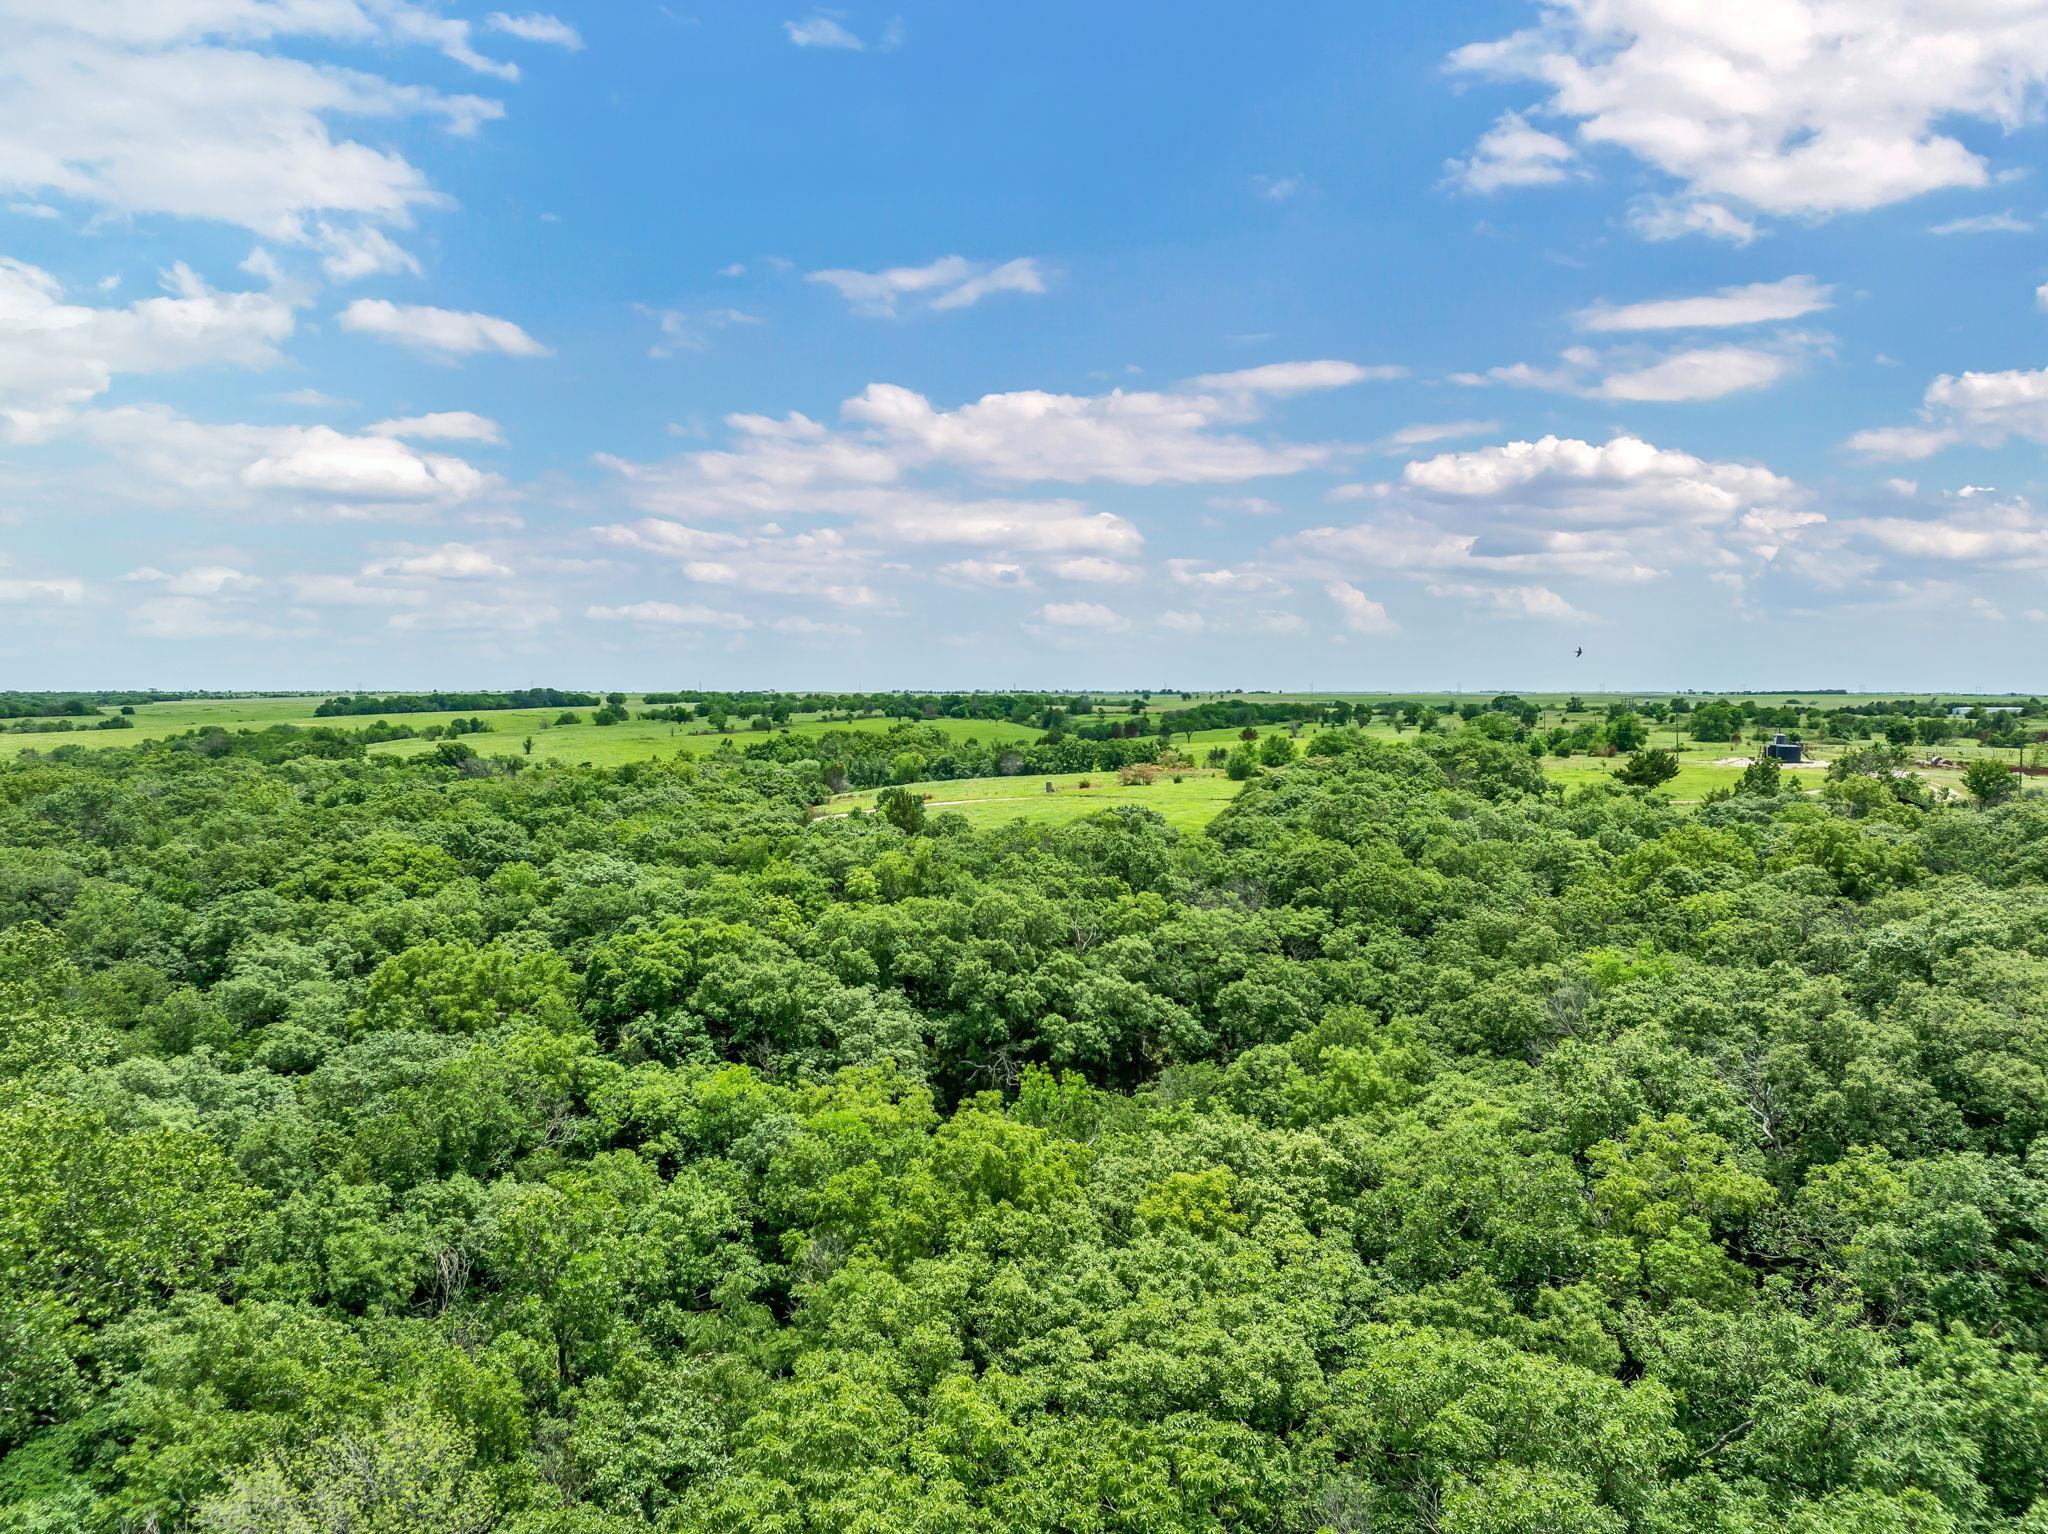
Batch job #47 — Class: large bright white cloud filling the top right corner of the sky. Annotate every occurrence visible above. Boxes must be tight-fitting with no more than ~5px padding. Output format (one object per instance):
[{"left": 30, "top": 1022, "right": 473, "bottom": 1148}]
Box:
[{"left": 1452, "top": 0, "right": 2048, "bottom": 226}]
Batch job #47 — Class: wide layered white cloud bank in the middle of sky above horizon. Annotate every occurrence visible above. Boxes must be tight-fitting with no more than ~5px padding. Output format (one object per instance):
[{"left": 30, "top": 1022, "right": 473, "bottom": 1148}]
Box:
[{"left": 598, "top": 363, "right": 1372, "bottom": 606}]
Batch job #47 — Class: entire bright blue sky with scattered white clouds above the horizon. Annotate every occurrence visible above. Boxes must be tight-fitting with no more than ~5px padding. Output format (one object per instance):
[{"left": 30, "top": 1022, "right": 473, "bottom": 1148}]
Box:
[{"left": 12, "top": 0, "right": 2048, "bottom": 690}]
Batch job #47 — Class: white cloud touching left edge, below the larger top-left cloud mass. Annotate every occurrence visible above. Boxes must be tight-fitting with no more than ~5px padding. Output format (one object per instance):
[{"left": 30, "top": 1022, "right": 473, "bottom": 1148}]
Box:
[{"left": 0, "top": 258, "right": 293, "bottom": 436}]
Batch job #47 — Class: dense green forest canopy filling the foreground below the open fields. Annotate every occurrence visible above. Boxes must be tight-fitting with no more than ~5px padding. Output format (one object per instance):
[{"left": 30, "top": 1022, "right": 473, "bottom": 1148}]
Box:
[{"left": 0, "top": 720, "right": 2048, "bottom": 1534}]
